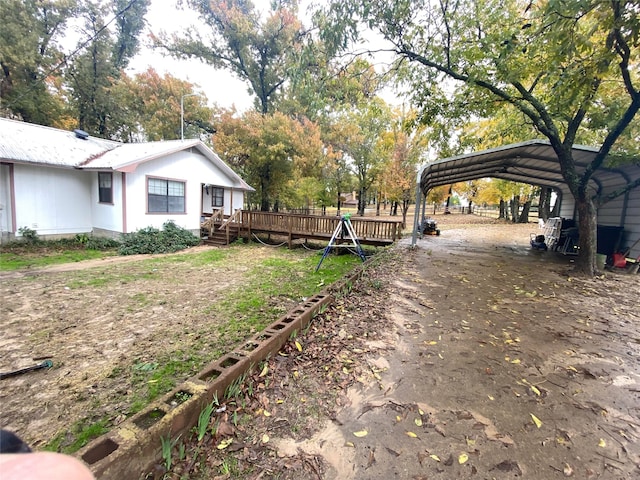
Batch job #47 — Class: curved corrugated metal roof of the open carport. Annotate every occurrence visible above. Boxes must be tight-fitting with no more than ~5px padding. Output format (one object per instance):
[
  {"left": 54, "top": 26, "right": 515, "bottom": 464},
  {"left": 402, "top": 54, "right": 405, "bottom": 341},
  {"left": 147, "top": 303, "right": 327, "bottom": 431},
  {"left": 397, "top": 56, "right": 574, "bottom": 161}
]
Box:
[{"left": 420, "top": 140, "right": 640, "bottom": 195}]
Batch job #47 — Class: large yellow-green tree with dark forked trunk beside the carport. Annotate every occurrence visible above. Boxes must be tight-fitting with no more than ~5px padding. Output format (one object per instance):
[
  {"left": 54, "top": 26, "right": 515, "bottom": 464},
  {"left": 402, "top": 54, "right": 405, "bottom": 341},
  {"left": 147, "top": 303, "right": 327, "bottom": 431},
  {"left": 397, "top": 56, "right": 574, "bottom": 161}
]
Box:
[{"left": 317, "top": 0, "right": 640, "bottom": 275}]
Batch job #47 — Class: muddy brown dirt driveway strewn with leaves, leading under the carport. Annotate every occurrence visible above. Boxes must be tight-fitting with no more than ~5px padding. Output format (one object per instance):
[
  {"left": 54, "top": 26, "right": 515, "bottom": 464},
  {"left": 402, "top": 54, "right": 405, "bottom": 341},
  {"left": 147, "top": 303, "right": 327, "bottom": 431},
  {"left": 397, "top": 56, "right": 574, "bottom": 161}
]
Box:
[{"left": 169, "top": 215, "right": 640, "bottom": 480}]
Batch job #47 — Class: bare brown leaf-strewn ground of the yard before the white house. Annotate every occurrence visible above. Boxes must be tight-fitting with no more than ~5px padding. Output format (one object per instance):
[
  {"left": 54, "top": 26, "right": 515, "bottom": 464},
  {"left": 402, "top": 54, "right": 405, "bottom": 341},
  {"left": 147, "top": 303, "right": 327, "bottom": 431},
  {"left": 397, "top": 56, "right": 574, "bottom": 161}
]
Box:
[{"left": 0, "top": 247, "right": 304, "bottom": 448}]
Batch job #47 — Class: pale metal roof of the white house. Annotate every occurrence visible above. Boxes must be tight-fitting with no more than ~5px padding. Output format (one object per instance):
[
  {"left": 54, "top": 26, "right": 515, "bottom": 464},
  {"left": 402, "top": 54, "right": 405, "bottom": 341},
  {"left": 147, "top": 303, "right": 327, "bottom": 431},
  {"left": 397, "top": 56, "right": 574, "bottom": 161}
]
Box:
[{"left": 0, "top": 118, "right": 254, "bottom": 191}]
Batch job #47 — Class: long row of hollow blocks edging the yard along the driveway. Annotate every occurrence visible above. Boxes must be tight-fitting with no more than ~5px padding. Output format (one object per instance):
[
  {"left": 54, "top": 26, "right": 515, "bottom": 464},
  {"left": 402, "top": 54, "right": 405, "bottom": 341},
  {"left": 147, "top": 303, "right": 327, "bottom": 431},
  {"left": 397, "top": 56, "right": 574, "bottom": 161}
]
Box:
[{"left": 75, "top": 261, "right": 369, "bottom": 480}]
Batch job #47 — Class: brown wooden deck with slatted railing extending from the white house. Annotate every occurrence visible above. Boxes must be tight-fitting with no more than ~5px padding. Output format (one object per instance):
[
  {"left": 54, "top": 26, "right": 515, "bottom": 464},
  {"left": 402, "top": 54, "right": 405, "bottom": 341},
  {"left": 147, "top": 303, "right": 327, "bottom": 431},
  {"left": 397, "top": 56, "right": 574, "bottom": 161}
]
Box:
[{"left": 239, "top": 210, "right": 402, "bottom": 247}]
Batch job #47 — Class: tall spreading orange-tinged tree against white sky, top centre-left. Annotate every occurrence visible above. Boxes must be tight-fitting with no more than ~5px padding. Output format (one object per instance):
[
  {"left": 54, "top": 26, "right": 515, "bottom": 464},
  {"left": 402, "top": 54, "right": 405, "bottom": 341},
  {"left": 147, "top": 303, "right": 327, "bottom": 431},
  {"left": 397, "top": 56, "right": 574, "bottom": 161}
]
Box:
[{"left": 154, "top": 0, "right": 304, "bottom": 114}]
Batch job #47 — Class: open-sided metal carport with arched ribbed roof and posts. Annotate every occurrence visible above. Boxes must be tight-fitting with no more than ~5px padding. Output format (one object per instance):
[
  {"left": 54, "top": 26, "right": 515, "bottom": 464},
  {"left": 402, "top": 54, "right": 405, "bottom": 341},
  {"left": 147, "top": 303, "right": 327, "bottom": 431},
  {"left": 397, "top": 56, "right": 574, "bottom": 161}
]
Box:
[{"left": 413, "top": 140, "right": 640, "bottom": 257}]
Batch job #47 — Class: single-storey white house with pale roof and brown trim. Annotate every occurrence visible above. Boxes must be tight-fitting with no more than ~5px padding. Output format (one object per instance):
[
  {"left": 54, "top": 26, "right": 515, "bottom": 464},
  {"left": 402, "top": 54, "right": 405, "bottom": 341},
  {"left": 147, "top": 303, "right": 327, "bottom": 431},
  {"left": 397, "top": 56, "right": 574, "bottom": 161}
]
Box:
[{"left": 0, "top": 118, "right": 253, "bottom": 241}]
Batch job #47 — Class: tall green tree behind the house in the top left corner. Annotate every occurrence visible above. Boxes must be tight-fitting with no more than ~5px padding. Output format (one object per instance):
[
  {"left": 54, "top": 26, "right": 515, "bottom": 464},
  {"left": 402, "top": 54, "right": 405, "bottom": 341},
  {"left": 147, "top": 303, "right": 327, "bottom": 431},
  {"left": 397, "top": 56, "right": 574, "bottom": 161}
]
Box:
[{"left": 0, "top": 0, "right": 77, "bottom": 126}]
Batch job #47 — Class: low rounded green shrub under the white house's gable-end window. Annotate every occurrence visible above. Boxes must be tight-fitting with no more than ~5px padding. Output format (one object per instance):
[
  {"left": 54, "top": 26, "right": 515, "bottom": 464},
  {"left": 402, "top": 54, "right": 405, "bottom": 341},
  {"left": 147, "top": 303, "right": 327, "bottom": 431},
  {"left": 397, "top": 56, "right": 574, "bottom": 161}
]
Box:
[{"left": 119, "top": 221, "right": 200, "bottom": 255}]
